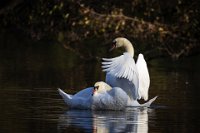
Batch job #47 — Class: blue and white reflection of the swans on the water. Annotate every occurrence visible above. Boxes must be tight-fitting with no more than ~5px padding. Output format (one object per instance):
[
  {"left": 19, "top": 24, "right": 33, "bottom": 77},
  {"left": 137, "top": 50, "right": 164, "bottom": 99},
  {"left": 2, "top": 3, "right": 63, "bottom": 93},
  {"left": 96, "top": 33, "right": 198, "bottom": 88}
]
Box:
[{"left": 58, "top": 108, "right": 149, "bottom": 133}]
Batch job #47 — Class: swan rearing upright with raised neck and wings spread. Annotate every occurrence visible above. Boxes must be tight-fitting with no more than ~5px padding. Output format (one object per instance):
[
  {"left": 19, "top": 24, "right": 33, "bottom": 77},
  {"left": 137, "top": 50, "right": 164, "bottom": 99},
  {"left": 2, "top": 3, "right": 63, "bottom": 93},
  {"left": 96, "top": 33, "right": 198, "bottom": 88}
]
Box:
[{"left": 102, "top": 37, "right": 156, "bottom": 106}]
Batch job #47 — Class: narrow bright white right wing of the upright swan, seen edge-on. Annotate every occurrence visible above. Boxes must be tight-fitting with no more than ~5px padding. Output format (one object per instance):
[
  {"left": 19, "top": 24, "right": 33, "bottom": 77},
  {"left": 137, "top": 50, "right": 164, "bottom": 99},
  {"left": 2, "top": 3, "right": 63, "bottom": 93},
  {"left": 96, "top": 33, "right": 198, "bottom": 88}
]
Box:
[{"left": 136, "top": 54, "right": 150, "bottom": 100}]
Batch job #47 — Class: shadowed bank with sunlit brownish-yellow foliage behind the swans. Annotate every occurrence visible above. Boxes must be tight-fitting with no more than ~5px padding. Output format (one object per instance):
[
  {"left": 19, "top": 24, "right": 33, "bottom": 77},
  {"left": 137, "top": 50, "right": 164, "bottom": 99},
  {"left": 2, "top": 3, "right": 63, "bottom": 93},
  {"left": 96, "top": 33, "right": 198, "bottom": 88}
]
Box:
[{"left": 0, "top": 0, "right": 200, "bottom": 59}]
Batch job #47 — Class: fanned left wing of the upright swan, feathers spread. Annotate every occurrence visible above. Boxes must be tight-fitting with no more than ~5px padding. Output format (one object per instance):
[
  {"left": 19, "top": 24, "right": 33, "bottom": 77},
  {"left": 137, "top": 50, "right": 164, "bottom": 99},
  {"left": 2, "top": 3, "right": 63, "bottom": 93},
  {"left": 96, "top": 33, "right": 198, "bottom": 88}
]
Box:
[{"left": 102, "top": 53, "right": 139, "bottom": 99}]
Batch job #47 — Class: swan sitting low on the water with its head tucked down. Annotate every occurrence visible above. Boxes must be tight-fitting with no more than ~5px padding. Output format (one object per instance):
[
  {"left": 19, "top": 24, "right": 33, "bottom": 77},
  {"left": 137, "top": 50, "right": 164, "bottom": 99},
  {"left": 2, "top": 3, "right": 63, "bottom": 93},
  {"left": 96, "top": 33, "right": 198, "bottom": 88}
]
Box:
[{"left": 58, "top": 81, "right": 128, "bottom": 110}]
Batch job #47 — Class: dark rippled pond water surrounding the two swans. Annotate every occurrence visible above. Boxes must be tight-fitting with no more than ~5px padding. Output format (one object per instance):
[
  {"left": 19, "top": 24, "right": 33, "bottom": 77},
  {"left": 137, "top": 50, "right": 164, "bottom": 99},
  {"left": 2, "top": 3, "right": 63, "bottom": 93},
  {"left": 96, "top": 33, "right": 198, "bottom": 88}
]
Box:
[{"left": 0, "top": 33, "right": 200, "bottom": 133}]
